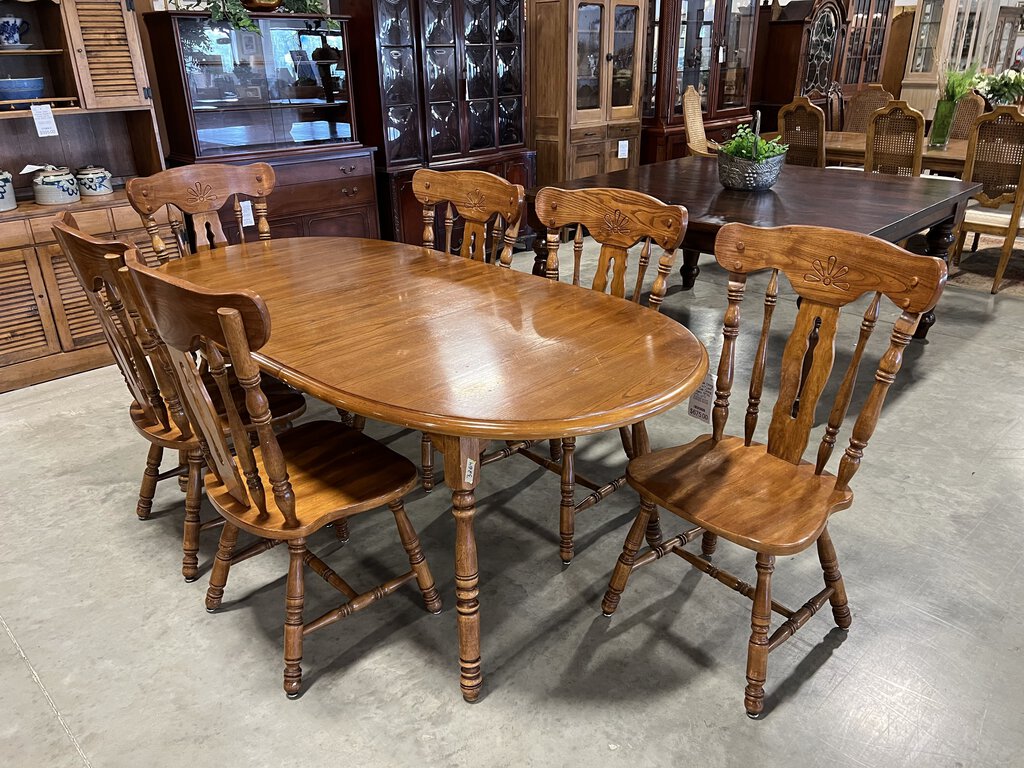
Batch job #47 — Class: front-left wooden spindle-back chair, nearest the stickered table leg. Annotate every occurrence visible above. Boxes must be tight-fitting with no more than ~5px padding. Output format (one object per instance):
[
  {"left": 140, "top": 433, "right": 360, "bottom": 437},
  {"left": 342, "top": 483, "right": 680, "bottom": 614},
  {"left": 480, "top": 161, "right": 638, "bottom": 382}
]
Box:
[{"left": 120, "top": 256, "right": 440, "bottom": 697}]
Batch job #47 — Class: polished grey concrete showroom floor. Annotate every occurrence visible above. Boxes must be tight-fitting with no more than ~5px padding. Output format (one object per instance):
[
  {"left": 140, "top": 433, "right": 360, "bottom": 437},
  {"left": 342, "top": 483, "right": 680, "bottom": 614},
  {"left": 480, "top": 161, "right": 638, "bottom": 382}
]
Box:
[{"left": 0, "top": 249, "right": 1024, "bottom": 768}]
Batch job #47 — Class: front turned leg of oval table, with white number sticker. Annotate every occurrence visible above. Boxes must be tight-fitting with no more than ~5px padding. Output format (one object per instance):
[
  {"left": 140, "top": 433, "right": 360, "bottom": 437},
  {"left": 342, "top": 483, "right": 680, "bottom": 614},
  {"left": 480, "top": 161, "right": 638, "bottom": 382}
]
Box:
[{"left": 435, "top": 435, "right": 483, "bottom": 701}]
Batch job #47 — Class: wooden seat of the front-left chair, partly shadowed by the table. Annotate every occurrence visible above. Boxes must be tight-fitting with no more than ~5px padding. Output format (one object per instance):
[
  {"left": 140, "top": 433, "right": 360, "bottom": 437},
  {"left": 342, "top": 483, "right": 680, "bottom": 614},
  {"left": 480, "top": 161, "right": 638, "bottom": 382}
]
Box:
[{"left": 206, "top": 421, "right": 418, "bottom": 539}]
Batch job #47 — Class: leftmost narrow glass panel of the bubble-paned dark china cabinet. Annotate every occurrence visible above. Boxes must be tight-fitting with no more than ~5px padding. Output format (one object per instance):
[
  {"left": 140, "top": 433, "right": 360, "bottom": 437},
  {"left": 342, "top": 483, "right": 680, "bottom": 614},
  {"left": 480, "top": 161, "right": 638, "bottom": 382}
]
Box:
[{"left": 377, "top": 0, "right": 423, "bottom": 162}]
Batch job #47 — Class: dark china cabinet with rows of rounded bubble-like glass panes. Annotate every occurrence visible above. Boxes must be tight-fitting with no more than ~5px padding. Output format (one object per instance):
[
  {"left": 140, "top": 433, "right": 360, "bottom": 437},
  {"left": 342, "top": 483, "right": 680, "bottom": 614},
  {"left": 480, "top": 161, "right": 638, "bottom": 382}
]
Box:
[{"left": 335, "top": 0, "right": 536, "bottom": 243}]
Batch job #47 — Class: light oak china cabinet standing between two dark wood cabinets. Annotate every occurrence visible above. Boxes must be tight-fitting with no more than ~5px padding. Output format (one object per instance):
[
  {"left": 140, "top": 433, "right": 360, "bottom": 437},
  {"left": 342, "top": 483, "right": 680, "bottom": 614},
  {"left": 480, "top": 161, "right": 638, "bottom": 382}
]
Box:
[{"left": 528, "top": 0, "right": 647, "bottom": 184}]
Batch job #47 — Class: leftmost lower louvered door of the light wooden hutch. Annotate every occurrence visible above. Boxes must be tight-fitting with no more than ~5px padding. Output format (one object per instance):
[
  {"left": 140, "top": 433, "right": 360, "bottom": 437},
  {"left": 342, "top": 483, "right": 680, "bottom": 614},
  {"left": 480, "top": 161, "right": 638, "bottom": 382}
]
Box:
[{"left": 0, "top": 248, "right": 60, "bottom": 366}]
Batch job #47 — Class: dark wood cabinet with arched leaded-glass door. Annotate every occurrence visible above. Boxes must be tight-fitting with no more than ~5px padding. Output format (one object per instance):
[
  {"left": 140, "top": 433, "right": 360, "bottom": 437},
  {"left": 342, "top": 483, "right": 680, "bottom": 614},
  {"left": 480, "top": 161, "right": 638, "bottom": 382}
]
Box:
[{"left": 752, "top": 0, "right": 847, "bottom": 130}]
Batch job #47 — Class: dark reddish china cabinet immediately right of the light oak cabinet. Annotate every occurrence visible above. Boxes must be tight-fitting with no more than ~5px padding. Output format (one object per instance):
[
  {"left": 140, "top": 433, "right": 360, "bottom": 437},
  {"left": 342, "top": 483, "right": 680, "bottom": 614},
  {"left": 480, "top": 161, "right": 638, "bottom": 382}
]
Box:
[{"left": 640, "top": 0, "right": 759, "bottom": 163}]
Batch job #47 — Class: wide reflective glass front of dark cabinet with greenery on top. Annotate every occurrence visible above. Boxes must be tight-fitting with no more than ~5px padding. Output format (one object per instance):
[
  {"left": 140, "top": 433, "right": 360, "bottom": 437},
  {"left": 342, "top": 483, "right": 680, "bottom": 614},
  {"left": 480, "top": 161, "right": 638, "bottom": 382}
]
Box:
[{"left": 175, "top": 16, "right": 355, "bottom": 158}]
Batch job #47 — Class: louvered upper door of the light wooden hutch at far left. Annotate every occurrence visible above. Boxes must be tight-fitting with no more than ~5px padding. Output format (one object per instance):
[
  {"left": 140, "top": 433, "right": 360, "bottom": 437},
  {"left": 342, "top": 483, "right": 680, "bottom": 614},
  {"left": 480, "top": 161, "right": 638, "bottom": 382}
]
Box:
[{"left": 60, "top": 0, "right": 150, "bottom": 110}]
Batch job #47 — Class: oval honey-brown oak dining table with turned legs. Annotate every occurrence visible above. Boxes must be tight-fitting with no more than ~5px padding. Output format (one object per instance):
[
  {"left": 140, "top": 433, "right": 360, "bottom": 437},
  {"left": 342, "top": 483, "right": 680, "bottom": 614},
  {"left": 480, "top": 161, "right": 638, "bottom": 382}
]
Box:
[{"left": 155, "top": 238, "right": 708, "bottom": 701}]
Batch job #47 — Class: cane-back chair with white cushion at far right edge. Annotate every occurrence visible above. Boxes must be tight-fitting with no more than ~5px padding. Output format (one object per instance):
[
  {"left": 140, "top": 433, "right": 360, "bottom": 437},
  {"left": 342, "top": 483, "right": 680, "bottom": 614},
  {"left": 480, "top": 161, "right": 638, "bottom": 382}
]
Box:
[{"left": 952, "top": 104, "right": 1024, "bottom": 293}]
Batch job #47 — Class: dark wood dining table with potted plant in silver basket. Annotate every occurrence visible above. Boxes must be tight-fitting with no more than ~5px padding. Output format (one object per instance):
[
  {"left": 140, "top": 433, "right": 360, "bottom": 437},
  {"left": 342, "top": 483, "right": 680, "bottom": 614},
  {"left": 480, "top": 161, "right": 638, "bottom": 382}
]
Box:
[{"left": 526, "top": 157, "right": 981, "bottom": 338}]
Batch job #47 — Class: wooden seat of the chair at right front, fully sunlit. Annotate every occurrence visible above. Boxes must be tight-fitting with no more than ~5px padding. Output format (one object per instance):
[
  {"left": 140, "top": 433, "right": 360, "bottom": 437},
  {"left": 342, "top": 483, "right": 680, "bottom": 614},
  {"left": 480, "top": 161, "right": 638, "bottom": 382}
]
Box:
[{"left": 626, "top": 435, "right": 853, "bottom": 555}]
